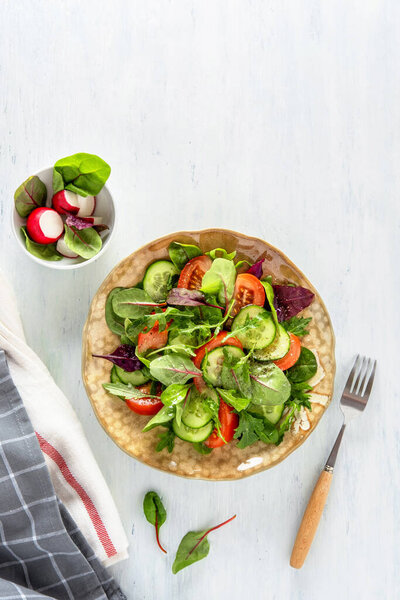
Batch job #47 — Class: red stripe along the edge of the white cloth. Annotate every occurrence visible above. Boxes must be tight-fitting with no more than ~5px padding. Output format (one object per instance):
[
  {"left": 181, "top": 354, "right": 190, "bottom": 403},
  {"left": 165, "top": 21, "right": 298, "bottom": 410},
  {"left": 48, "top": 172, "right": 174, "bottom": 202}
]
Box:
[{"left": 35, "top": 431, "right": 117, "bottom": 558}]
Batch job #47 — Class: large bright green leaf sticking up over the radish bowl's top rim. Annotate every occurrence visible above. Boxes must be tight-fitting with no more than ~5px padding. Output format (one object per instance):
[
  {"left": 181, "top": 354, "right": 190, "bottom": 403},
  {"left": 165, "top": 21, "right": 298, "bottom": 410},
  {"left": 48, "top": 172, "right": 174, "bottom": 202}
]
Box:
[{"left": 53, "top": 152, "right": 111, "bottom": 196}]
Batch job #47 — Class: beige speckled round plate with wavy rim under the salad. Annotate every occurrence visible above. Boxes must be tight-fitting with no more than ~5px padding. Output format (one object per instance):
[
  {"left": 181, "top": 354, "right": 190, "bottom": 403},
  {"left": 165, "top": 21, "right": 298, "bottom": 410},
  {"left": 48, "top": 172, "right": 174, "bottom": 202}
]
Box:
[{"left": 82, "top": 229, "right": 335, "bottom": 480}]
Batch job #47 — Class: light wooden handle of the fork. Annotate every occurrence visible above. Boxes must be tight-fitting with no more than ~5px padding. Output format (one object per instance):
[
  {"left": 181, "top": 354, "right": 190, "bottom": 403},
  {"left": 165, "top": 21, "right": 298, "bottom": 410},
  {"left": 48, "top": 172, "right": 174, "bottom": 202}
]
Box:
[{"left": 290, "top": 468, "right": 333, "bottom": 569}]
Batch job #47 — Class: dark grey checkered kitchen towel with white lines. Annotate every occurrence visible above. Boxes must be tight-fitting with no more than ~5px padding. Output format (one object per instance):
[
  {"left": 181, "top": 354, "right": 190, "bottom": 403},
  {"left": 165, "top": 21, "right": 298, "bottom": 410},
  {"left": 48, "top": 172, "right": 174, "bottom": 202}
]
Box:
[{"left": 0, "top": 350, "right": 126, "bottom": 600}]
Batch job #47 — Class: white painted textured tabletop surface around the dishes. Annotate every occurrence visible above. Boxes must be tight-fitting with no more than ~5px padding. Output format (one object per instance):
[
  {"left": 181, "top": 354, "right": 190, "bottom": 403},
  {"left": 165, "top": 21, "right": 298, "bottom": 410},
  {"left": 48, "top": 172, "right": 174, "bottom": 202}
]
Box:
[{"left": 0, "top": 0, "right": 400, "bottom": 600}]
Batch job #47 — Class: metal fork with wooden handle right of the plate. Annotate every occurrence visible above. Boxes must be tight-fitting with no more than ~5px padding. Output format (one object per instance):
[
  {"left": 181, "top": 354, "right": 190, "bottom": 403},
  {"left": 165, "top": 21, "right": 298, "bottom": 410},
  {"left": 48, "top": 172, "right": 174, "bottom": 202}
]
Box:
[{"left": 290, "top": 355, "right": 376, "bottom": 569}]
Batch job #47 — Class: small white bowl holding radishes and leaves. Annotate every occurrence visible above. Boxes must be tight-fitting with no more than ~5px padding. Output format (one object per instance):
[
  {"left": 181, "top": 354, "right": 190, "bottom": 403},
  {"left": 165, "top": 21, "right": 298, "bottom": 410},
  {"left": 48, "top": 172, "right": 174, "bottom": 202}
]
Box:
[{"left": 12, "top": 167, "right": 115, "bottom": 269}]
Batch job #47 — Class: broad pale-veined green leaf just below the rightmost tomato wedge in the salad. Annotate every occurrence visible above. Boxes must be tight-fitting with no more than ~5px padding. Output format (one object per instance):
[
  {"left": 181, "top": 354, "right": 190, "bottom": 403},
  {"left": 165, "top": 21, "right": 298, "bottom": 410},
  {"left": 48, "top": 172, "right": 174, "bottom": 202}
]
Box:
[{"left": 250, "top": 361, "right": 290, "bottom": 406}]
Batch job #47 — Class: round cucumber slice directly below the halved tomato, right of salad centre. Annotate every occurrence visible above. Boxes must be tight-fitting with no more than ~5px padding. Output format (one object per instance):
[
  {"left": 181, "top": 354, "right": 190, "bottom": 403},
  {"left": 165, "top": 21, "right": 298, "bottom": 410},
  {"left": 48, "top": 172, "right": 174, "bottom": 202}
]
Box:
[{"left": 232, "top": 304, "right": 276, "bottom": 350}]
